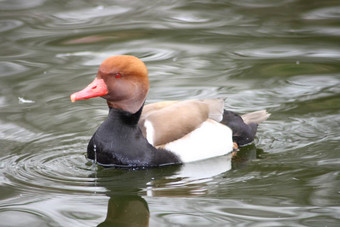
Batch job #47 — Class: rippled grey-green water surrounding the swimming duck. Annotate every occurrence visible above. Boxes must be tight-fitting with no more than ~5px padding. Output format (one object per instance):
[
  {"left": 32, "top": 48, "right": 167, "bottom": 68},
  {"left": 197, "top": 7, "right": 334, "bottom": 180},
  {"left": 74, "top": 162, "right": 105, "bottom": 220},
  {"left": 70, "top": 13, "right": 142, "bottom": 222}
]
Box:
[{"left": 0, "top": 0, "right": 340, "bottom": 226}]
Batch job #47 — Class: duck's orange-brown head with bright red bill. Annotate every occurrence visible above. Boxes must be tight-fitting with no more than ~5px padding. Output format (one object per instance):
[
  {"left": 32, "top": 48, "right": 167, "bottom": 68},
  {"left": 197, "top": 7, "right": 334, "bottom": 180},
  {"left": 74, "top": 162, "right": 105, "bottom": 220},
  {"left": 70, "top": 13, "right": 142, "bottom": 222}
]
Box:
[{"left": 70, "top": 55, "right": 149, "bottom": 113}]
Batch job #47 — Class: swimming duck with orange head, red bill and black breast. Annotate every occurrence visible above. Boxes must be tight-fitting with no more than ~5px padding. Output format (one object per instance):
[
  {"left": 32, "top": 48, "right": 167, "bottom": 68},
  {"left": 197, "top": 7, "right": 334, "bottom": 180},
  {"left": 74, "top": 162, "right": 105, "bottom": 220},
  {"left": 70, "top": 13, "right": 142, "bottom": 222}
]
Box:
[{"left": 70, "top": 55, "right": 270, "bottom": 168}]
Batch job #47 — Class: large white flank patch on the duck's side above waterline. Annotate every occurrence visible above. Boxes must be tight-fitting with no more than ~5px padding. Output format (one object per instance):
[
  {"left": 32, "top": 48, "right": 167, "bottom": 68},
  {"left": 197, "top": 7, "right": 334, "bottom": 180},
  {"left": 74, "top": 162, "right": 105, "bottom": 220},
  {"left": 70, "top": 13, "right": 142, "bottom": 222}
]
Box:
[{"left": 164, "top": 119, "right": 233, "bottom": 162}]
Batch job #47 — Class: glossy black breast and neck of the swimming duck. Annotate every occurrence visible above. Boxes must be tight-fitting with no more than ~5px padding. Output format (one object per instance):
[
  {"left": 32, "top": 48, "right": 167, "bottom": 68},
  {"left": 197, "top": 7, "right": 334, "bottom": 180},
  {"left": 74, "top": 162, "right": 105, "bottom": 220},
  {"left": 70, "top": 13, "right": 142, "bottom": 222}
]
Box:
[{"left": 87, "top": 108, "right": 181, "bottom": 167}]
